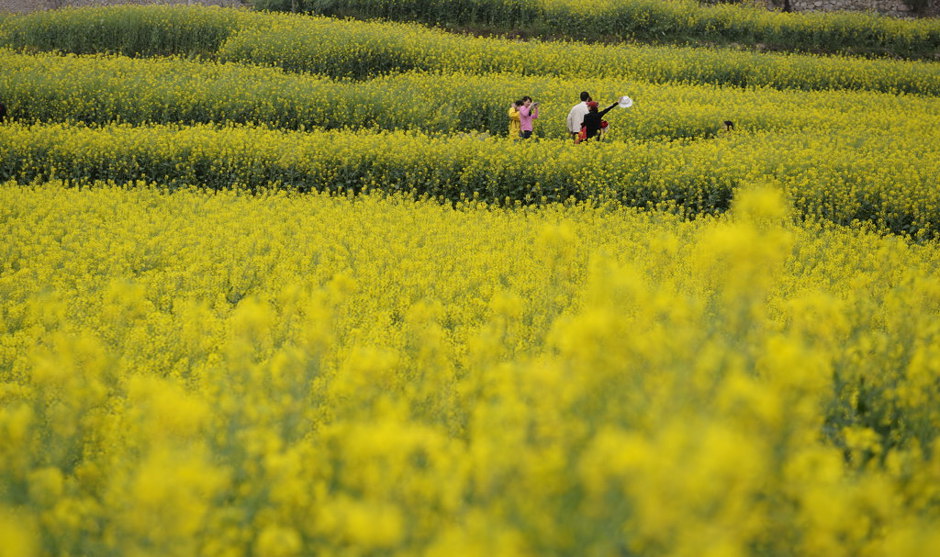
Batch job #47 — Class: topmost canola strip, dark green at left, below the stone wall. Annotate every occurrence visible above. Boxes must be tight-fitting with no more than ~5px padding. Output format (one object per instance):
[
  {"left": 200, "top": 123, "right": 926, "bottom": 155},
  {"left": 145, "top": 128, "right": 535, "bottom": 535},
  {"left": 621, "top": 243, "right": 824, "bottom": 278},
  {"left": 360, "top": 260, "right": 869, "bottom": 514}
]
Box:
[{"left": 252, "top": 0, "right": 940, "bottom": 60}]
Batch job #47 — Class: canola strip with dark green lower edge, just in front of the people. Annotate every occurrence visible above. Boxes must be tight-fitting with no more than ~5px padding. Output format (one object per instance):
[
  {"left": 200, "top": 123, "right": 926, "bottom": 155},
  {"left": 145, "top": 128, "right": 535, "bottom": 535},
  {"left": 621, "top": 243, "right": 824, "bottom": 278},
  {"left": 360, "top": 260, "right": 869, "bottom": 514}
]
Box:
[{"left": 0, "top": 120, "right": 940, "bottom": 238}]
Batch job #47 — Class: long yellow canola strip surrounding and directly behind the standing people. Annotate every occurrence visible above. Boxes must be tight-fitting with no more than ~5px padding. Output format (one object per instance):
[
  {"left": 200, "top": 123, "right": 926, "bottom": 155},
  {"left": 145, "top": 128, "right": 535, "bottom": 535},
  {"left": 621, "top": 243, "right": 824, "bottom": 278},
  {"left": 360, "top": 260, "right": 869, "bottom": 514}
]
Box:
[{"left": 0, "top": 50, "right": 940, "bottom": 143}]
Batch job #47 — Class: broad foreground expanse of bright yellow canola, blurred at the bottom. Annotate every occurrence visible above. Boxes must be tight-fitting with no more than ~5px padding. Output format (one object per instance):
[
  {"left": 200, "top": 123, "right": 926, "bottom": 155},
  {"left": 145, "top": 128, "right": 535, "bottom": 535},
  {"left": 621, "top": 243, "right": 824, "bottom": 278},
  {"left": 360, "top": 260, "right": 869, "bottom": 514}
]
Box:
[{"left": 0, "top": 183, "right": 940, "bottom": 556}]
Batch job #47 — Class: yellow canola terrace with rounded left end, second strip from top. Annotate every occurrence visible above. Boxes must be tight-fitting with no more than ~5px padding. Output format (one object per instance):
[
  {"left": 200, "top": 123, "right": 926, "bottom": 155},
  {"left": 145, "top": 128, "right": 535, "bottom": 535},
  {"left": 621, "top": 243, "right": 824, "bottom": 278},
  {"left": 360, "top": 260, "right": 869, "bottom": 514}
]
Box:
[{"left": 219, "top": 15, "right": 940, "bottom": 95}]
